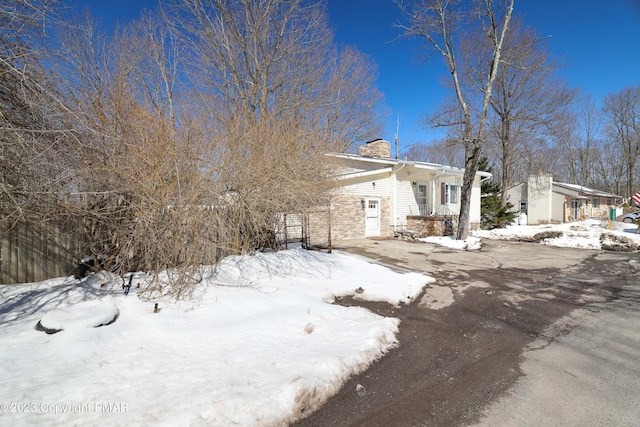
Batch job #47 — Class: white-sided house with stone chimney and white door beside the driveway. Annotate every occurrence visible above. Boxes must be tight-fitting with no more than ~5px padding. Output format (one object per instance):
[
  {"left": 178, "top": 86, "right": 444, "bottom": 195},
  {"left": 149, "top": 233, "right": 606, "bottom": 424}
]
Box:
[{"left": 330, "top": 140, "right": 491, "bottom": 240}]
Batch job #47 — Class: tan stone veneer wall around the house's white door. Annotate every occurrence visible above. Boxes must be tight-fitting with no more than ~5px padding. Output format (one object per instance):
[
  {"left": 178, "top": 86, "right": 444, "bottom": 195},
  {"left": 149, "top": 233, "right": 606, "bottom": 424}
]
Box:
[{"left": 331, "top": 194, "right": 393, "bottom": 241}]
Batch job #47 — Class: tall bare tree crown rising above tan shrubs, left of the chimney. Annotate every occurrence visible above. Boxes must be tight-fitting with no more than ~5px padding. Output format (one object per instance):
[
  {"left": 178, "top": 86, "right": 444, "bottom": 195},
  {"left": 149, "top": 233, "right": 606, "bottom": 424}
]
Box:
[{"left": 165, "top": 0, "right": 382, "bottom": 149}]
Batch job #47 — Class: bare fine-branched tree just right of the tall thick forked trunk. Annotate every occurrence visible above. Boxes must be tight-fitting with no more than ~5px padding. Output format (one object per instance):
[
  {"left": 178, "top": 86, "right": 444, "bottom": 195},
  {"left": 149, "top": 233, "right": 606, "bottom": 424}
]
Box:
[{"left": 464, "top": 20, "right": 577, "bottom": 204}]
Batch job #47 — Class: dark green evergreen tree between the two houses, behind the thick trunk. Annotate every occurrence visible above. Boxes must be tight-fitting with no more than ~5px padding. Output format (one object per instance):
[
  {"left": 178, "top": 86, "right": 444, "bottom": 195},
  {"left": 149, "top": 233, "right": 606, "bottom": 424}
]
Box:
[{"left": 478, "top": 157, "right": 516, "bottom": 230}]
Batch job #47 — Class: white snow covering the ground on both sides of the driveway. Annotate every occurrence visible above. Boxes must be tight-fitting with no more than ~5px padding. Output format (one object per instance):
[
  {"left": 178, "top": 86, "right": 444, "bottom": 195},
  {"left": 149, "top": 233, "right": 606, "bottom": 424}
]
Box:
[{"left": 0, "top": 222, "right": 640, "bottom": 426}]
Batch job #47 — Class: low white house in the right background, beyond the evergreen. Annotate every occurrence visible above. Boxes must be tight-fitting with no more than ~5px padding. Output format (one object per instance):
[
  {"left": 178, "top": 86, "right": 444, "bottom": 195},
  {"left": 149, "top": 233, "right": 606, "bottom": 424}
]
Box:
[{"left": 506, "top": 174, "right": 621, "bottom": 224}]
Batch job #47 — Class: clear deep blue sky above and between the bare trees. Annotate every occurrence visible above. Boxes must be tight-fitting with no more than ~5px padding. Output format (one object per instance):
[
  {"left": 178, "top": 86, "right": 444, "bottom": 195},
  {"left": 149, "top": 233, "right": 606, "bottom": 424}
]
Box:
[{"left": 70, "top": 0, "right": 640, "bottom": 154}]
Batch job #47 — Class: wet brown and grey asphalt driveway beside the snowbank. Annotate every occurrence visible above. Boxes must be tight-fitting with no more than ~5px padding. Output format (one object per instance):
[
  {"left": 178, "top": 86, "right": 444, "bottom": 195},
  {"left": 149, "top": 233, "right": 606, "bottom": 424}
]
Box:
[{"left": 296, "top": 240, "right": 640, "bottom": 426}]
